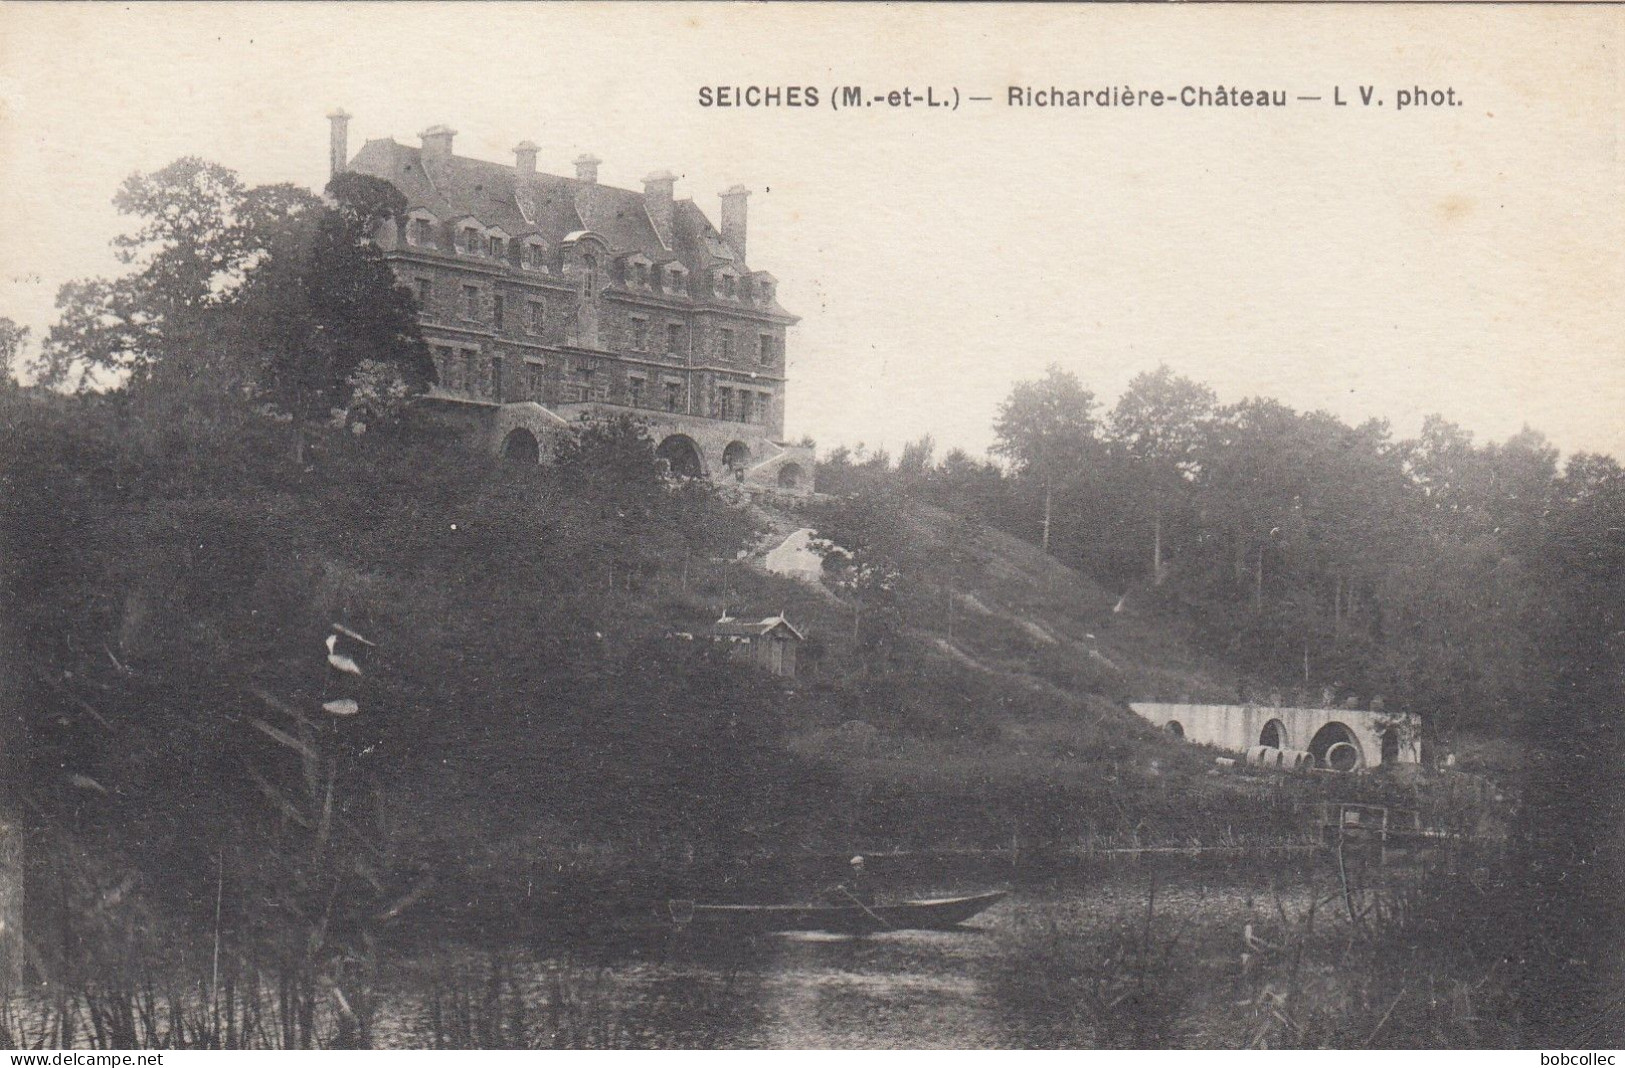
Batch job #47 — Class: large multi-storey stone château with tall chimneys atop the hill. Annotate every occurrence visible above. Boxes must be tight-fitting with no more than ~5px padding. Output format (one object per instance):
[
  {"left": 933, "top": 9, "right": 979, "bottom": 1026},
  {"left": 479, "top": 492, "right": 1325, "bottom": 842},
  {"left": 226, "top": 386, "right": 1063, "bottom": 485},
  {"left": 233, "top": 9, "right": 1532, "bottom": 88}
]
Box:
[{"left": 328, "top": 111, "right": 813, "bottom": 493}]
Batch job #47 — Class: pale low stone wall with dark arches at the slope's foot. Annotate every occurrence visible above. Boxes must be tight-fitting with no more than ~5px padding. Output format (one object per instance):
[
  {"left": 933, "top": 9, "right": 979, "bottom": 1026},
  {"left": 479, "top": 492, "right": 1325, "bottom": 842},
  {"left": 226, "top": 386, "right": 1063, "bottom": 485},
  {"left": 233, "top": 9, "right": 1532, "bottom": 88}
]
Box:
[{"left": 1128, "top": 701, "right": 1422, "bottom": 769}]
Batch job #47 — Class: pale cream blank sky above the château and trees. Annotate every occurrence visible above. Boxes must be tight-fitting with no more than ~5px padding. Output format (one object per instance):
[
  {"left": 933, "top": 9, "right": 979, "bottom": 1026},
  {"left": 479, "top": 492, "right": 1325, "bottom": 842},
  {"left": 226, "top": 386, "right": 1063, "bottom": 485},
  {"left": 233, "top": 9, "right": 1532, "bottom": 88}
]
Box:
[{"left": 0, "top": 3, "right": 1625, "bottom": 457}]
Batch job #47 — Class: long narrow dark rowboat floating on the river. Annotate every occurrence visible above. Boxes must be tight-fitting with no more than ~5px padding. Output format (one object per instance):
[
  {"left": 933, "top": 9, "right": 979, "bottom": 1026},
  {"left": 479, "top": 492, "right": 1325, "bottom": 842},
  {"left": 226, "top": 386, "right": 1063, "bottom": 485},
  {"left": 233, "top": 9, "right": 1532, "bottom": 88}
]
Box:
[{"left": 666, "top": 891, "right": 1008, "bottom": 935}]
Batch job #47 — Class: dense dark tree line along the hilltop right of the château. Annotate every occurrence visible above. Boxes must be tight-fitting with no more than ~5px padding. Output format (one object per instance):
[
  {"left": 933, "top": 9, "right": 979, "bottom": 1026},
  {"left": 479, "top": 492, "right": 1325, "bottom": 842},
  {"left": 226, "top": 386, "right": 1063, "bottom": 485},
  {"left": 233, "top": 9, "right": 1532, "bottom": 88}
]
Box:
[{"left": 819, "top": 367, "right": 1625, "bottom": 744}]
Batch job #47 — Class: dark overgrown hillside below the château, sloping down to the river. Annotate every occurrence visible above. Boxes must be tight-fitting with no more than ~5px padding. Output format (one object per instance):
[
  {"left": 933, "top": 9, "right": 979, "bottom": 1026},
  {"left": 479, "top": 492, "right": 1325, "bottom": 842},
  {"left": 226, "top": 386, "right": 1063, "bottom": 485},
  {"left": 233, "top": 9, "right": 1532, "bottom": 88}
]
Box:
[{"left": 5, "top": 391, "right": 1475, "bottom": 949}]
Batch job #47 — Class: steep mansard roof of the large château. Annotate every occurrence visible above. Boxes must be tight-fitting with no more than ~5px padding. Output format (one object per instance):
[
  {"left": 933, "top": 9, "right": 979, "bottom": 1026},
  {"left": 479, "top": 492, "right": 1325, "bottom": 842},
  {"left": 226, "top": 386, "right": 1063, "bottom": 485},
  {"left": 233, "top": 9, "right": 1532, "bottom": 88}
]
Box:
[{"left": 349, "top": 138, "right": 788, "bottom": 315}]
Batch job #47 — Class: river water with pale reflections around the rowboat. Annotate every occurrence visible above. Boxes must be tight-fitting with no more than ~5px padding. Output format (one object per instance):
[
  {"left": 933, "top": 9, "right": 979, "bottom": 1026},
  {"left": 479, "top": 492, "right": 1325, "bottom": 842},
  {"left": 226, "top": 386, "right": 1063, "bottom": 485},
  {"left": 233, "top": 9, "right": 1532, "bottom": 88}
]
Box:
[{"left": 379, "top": 853, "right": 1334, "bottom": 1048}]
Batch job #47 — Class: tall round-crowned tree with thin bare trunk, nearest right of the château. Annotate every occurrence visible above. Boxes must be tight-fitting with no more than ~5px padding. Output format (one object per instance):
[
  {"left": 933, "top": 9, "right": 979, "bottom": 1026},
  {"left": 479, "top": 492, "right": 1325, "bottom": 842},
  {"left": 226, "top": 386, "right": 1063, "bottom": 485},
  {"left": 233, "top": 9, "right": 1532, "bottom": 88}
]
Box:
[{"left": 993, "top": 364, "right": 1100, "bottom": 553}]
